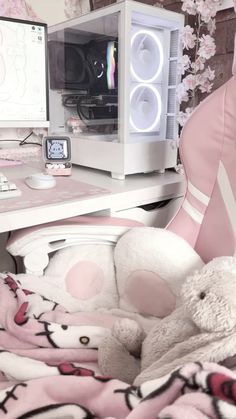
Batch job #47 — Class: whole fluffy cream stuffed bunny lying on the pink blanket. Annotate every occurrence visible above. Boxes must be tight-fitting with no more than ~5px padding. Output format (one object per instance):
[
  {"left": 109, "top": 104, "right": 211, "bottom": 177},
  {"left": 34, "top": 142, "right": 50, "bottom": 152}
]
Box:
[{"left": 98, "top": 257, "right": 236, "bottom": 385}]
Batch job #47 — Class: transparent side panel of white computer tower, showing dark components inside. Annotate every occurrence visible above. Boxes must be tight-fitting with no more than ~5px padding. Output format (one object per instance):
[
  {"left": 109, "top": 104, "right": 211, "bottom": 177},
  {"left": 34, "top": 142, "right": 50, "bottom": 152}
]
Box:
[{"left": 48, "top": 13, "right": 119, "bottom": 141}]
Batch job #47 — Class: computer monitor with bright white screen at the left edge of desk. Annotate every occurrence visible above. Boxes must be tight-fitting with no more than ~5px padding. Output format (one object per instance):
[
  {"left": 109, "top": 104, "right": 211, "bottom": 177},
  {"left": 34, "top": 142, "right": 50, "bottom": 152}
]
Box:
[{"left": 0, "top": 16, "right": 49, "bottom": 128}]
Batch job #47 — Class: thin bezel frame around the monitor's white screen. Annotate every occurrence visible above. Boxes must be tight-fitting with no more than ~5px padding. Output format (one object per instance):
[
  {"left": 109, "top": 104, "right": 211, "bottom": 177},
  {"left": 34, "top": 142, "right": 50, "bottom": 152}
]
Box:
[{"left": 0, "top": 16, "right": 50, "bottom": 128}]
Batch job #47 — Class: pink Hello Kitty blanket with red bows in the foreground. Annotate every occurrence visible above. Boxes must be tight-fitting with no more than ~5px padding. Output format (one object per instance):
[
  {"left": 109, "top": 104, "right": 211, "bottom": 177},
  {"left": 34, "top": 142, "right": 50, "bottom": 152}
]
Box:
[{"left": 0, "top": 275, "right": 236, "bottom": 419}]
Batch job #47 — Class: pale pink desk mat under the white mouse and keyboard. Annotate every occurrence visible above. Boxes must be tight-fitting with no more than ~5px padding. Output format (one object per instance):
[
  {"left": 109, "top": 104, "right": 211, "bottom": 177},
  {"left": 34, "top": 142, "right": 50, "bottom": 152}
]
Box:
[{"left": 0, "top": 177, "right": 110, "bottom": 213}]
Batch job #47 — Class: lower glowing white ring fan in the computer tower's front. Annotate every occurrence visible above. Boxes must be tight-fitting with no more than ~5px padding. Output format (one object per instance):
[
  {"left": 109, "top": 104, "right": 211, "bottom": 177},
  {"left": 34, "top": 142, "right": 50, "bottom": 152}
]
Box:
[{"left": 130, "top": 83, "right": 162, "bottom": 132}]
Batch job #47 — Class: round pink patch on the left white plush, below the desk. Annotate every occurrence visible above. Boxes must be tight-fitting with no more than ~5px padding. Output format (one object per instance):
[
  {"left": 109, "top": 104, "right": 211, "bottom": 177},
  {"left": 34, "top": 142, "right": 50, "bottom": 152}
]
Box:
[{"left": 65, "top": 261, "right": 104, "bottom": 300}]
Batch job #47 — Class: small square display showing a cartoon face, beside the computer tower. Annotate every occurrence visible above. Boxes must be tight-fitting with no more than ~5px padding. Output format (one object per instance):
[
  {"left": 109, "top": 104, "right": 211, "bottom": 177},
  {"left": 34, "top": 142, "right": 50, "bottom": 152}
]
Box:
[{"left": 44, "top": 137, "right": 70, "bottom": 161}]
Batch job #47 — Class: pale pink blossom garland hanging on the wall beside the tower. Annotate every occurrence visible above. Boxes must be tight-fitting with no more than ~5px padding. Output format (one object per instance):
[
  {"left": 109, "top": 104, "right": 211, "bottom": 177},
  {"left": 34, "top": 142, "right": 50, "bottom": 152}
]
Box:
[{"left": 177, "top": 0, "right": 220, "bottom": 126}]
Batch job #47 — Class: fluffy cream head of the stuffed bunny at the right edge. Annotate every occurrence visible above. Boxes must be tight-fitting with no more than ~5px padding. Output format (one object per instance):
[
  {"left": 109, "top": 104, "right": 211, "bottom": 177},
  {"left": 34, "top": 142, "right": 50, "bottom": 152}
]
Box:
[{"left": 181, "top": 268, "right": 236, "bottom": 332}]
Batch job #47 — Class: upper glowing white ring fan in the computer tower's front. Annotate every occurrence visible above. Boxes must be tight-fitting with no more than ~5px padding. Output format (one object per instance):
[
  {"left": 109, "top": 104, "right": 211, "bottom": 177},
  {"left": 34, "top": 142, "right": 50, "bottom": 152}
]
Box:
[{"left": 130, "top": 30, "right": 164, "bottom": 83}]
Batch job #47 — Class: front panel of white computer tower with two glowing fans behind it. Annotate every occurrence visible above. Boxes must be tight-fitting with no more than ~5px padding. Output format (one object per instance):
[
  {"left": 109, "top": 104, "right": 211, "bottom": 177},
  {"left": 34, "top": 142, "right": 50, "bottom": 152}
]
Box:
[{"left": 129, "top": 11, "right": 177, "bottom": 142}]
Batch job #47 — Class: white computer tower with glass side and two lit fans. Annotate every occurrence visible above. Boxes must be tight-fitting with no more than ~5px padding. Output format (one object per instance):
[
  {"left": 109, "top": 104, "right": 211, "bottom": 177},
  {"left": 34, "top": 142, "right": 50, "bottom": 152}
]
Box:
[{"left": 48, "top": 0, "right": 184, "bottom": 179}]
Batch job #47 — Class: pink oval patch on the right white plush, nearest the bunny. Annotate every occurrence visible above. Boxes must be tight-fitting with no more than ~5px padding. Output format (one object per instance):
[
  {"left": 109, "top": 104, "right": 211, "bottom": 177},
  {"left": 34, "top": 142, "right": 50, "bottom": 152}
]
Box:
[{"left": 124, "top": 270, "right": 175, "bottom": 318}]
